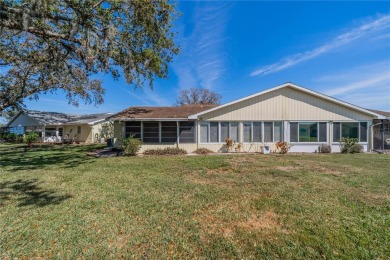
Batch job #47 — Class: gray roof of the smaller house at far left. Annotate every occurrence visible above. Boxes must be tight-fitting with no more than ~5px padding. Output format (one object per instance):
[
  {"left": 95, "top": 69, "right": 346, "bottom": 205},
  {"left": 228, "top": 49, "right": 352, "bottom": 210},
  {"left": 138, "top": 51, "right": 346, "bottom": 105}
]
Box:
[{"left": 8, "top": 110, "right": 112, "bottom": 125}]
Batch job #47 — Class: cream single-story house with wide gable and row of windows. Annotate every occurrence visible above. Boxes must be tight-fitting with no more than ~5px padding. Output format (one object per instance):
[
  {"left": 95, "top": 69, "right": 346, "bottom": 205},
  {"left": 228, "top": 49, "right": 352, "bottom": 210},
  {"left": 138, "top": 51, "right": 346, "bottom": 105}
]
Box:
[{"left": 107, "top": 83, "right": 386, "bottom": 152}]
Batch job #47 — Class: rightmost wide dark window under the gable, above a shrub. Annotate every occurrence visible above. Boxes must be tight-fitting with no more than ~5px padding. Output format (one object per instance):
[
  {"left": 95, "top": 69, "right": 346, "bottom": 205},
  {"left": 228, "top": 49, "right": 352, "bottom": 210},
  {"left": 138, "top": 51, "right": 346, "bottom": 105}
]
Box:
[{"left": 333, "top": 122, "right": 368, "bottom": 142}]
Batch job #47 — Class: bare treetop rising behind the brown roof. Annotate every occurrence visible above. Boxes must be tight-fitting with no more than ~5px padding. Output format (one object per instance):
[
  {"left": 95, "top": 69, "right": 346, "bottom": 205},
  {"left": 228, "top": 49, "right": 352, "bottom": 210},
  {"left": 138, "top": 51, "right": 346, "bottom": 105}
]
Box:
[{"left": 176, "top": 88, "right": 222, "bottom": 105}]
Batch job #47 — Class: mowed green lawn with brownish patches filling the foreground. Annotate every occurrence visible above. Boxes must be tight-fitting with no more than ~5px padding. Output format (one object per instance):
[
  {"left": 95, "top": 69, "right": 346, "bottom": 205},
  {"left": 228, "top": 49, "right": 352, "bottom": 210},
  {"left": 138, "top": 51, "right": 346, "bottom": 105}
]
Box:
[{"left": 0, "top": 145, "right": 390, "bottom": 259}]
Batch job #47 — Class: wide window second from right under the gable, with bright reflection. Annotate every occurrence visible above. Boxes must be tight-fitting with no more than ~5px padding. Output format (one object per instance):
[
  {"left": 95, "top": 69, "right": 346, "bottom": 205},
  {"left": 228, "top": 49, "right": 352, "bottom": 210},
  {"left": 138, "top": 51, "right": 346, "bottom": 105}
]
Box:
[{"left": 290, "top": 122, "right": 328, "bottom": 143}]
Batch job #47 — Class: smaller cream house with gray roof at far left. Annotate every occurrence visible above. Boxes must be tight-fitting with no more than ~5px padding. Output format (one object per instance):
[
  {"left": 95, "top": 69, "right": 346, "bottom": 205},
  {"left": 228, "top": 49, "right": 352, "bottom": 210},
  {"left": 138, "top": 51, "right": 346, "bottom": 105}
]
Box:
[{"left": 6, "top": 110, "right": 112, "bottom": 143}]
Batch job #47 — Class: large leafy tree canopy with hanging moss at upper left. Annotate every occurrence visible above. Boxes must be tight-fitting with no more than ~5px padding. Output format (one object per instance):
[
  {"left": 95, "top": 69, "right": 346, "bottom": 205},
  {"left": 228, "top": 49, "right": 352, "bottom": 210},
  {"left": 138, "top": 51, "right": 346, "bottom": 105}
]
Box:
[{"left": 0, "top": 0, "right": 178, "bottom": 112}]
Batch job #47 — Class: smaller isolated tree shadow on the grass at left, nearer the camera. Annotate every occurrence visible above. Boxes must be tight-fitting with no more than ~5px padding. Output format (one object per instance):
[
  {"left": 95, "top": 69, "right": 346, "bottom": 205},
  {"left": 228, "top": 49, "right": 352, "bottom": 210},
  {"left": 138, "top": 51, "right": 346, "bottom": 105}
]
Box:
[{"left": 0, "top": 179, "right": 72, "bottom": 207}]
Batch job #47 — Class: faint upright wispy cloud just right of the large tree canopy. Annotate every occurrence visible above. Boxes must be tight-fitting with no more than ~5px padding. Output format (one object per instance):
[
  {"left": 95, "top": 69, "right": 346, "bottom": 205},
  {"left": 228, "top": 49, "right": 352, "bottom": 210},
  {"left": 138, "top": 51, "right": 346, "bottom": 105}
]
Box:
[{"left": 172, "top": 2, "right": 230, "bottom": 89}]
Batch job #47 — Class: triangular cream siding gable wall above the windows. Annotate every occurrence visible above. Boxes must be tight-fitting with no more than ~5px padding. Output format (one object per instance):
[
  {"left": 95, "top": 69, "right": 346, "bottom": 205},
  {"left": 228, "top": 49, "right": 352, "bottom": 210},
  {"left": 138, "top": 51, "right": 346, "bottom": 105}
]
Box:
[{"left": 200, "top": 87, "right": 373, "bottom": 121}]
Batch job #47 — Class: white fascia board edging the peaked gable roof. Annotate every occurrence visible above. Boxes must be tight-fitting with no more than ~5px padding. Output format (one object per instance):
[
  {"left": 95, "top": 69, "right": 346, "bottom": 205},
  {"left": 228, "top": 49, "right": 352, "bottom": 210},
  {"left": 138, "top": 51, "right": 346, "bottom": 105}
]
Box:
[{"left": 188, "top": 83, "right": 385, "bottom": 119}]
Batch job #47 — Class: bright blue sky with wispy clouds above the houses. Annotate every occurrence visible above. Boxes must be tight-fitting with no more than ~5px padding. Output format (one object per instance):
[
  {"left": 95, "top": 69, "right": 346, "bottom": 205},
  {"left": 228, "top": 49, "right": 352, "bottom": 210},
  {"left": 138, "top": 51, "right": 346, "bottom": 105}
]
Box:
[{"left": 26, "top": 1, "right": 390, "bottom": 113}]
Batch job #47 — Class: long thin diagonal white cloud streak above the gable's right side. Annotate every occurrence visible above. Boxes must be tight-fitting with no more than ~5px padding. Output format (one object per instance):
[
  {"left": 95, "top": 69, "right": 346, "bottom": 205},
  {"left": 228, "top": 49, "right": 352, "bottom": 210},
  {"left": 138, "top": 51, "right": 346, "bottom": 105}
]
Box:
[{"left": 250, "top": 15, "right": 390, "bottom": 77}]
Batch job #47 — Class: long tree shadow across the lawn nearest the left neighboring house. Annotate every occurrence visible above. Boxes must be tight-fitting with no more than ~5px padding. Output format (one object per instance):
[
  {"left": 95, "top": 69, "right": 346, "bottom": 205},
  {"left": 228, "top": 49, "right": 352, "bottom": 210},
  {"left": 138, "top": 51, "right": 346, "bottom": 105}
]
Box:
[{"left": 0, "top": 146, "right": 99, "bottom": 171}]
